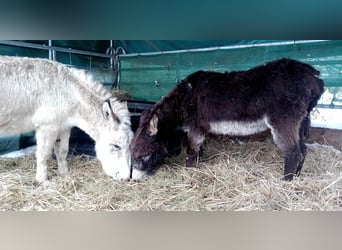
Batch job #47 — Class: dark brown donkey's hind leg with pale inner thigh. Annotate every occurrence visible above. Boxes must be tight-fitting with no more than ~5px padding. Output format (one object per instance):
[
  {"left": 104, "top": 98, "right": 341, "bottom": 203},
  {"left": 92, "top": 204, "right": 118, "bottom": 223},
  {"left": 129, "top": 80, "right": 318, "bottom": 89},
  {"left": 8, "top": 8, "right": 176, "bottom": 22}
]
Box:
[{"left": 270, "top": 118, "right": 306, "bottom": 181}]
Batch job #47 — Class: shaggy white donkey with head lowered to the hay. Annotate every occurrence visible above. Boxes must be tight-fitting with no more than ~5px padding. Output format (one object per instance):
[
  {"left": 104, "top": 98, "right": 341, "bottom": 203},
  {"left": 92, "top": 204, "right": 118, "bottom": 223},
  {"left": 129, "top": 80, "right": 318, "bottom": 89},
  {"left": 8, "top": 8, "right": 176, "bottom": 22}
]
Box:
[{"left": 0, "top": 56, "right": 133, "bottom": 183}]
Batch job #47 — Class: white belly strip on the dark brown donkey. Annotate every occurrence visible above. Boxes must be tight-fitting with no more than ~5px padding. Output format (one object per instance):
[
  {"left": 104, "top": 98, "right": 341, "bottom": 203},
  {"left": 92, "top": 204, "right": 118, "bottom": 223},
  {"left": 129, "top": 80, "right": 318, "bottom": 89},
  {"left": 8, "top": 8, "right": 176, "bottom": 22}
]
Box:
[{"left": 209, "top": 118, "right": 268, "bottom": 136}]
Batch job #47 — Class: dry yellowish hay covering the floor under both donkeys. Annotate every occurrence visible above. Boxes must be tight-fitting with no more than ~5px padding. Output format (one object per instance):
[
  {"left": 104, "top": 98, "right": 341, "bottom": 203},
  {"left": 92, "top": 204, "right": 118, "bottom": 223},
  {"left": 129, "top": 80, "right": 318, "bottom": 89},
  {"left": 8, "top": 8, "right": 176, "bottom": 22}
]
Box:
[{"left": 0, "top": 139, "right": 342, "bottom": 211}]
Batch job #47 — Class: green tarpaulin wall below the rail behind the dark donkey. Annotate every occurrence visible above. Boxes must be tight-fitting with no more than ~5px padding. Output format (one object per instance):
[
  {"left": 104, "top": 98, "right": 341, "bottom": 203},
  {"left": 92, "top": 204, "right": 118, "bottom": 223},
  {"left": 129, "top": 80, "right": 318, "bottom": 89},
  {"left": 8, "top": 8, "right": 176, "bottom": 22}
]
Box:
[{"left": 120, "top": 41, "right": 342, "bottom": 105}]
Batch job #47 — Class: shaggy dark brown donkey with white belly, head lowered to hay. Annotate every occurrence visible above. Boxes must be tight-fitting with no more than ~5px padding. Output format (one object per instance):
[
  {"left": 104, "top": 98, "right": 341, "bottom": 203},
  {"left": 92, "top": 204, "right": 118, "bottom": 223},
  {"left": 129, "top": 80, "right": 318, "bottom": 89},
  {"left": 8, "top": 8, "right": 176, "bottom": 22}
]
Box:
[{"left": 131, "top": 59, "right": 324, "bottom": 180}]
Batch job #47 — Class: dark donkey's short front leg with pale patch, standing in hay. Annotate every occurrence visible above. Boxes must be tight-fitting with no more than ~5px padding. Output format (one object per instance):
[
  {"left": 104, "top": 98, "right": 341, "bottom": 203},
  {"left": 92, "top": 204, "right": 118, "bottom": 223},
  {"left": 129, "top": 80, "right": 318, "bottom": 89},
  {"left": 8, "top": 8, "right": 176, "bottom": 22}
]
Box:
[{"left": 185, "top": 129, "right": 205, "bottom": 167}]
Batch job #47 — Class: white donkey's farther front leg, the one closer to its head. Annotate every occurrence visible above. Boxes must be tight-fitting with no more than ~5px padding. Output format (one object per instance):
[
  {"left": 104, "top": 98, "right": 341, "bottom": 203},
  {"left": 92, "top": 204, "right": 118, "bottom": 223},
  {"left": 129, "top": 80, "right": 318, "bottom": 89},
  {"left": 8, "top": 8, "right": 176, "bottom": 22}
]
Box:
[{"left": 54, "top": 129, "right": 71, "bottom": 175}]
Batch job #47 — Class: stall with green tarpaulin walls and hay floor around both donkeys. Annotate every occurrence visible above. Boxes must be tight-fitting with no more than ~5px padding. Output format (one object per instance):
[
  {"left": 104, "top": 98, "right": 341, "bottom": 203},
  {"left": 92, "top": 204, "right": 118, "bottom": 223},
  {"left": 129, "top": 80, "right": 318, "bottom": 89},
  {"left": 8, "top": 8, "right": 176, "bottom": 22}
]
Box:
[{"left": 0, "top": 40, "right": 342, "bottom": 211}]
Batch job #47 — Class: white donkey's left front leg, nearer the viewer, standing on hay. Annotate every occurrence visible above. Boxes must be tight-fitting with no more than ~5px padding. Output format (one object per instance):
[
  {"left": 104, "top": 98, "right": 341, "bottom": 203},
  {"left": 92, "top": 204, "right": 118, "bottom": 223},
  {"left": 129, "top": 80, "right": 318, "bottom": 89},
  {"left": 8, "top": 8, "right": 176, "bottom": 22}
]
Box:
[{"left": 36, "top": 127, "right": 57, "bottom": 183}]
